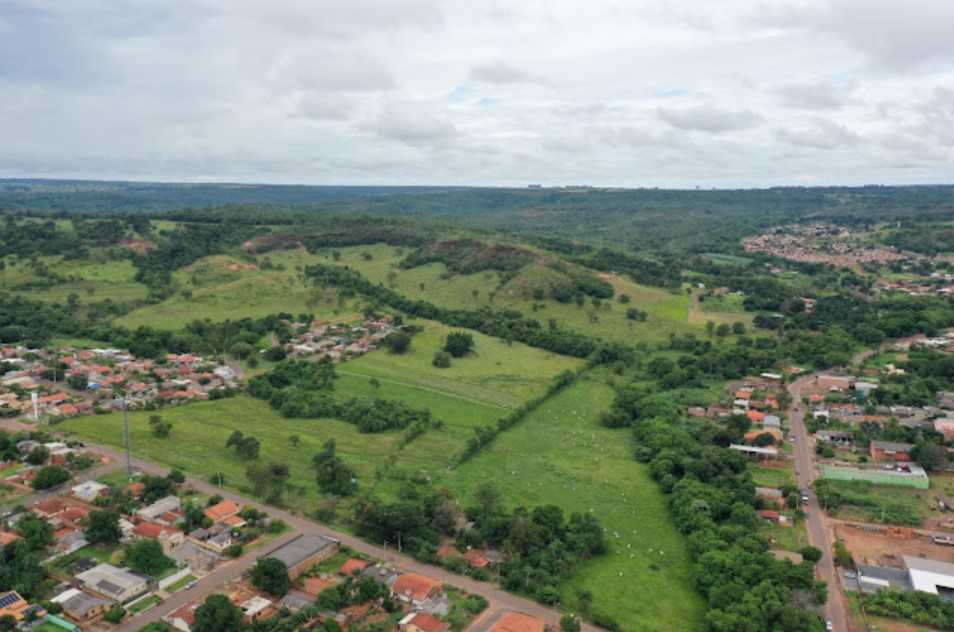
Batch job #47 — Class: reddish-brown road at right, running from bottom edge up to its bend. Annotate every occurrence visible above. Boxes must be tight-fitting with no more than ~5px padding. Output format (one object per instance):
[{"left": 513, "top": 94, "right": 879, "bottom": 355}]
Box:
[{"left": 788, "top": 376, "right": 854, "bottom": 632}]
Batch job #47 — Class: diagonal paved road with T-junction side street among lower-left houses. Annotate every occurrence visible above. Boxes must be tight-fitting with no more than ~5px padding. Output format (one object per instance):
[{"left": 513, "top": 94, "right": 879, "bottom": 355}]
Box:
[{"left": 88, "top": 444, "right": 600, "bottom": 632}]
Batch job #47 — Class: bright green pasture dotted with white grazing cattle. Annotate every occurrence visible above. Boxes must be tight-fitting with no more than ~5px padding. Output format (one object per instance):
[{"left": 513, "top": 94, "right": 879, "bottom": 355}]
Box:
[{"left": 436, "top": 379, "right": 703, "bottom": 631}]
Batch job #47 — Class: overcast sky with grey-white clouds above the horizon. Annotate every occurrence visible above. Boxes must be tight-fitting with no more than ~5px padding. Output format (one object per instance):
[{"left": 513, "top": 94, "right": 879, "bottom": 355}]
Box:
[{"left": 0, "top": 0, "right": 954, "bottom": 188}]
